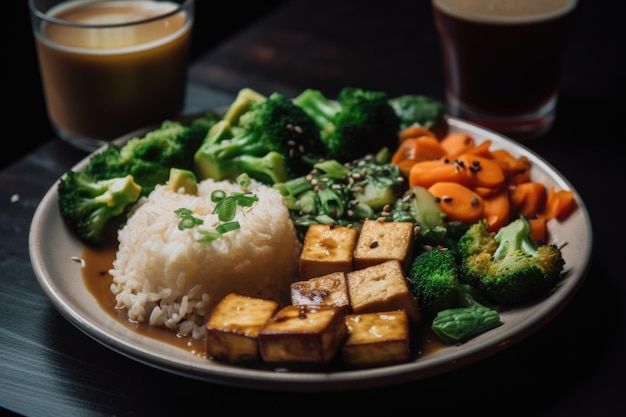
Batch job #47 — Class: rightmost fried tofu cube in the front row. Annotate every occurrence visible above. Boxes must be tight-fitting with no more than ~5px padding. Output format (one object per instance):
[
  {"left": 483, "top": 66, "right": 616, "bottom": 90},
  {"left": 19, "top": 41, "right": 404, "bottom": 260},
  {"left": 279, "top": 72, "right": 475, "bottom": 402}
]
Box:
[{"left": 341, "top": 310, "right": 411, "bottom": 368}]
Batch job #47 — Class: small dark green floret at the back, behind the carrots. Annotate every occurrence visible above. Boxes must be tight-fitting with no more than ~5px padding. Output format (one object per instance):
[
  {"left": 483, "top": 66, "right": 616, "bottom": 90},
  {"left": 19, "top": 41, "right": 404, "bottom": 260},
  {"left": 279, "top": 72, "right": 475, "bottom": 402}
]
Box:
[{"left": 389, "top": 94, "right": 445, "bottom": 129}]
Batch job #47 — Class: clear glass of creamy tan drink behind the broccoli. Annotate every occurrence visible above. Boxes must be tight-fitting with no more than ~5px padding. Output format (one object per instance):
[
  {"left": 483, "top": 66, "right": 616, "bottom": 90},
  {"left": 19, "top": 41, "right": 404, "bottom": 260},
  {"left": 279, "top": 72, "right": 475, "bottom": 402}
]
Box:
[{"left": 29, "top": 0, "right": 194, "bottom": 151}]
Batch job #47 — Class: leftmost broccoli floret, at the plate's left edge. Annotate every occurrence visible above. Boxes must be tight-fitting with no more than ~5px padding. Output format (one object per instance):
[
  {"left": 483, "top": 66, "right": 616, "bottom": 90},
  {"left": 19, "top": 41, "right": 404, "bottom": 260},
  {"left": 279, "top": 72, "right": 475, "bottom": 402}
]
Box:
[{"left": 57, "top": 170, "right": 141, "bottom": 246}]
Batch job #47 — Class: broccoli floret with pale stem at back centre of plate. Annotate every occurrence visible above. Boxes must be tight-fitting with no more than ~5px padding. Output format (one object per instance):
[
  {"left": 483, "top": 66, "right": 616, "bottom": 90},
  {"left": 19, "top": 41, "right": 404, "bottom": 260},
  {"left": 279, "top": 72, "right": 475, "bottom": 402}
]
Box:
[{"left": 294, "top": 87, "right": 400, "bottom": 162}]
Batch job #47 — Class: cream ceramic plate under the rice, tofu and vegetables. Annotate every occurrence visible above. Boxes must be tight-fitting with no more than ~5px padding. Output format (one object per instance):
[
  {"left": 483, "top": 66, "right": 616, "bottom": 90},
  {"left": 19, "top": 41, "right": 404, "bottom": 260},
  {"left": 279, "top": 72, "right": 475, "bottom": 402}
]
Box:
[{"left": 29, "top": 118, "right": 592, "bottom": 391}]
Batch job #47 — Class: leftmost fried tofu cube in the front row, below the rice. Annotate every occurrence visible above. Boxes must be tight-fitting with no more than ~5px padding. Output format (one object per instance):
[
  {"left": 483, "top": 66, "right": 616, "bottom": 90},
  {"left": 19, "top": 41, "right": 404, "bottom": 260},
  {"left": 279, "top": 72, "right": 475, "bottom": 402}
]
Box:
[{"left": 205, "top": 293, "right": 279, "bottom": 362}]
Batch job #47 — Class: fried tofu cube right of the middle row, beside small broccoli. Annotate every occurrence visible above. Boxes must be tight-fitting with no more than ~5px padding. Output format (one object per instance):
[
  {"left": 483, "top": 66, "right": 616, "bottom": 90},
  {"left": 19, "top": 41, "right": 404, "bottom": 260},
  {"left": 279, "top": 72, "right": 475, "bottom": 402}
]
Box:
[{"left": 346, "top": 259, "right": 421, "bottom": 321}]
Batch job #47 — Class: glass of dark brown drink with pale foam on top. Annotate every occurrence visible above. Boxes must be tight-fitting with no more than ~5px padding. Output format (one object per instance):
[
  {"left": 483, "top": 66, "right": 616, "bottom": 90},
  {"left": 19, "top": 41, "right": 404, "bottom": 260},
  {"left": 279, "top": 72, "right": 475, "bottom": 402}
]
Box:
[{"left": 432, "top": 0, "right": 577, "bottom": 141}]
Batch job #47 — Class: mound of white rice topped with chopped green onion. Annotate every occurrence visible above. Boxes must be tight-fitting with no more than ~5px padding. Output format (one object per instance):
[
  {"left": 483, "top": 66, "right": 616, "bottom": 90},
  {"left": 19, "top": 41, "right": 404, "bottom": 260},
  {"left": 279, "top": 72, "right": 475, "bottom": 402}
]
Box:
[{"left": 110, "top": 179, "right": 302, "bottom": 340}]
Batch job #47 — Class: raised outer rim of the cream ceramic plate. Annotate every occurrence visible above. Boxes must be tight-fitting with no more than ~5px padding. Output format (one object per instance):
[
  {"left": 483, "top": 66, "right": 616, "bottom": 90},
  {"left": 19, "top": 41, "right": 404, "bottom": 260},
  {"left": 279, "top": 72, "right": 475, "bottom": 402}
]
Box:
[{"left": 29, "top": 116, "right": 593, "bottom": 391}]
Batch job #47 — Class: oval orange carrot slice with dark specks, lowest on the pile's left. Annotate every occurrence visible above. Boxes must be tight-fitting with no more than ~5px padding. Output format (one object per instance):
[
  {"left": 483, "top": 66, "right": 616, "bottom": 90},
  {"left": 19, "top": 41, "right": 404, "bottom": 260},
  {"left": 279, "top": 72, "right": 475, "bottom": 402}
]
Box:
[{"left": 428, "top": 181, "right": 485, "bottom": 223}]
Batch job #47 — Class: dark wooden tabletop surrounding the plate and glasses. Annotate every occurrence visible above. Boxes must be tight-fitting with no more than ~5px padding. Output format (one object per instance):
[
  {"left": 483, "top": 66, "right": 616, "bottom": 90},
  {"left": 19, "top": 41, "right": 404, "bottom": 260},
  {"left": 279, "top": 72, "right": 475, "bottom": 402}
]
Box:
[{"left": 0, "top": 0, "right": 626, "bottom": 417}]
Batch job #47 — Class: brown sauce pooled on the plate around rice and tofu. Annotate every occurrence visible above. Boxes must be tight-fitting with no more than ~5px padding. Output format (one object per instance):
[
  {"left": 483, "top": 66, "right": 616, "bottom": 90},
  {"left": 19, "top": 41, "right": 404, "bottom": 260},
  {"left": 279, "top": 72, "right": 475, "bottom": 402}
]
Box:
[{"left": 82, "top": 245, "right": 447, "bottom": 371}]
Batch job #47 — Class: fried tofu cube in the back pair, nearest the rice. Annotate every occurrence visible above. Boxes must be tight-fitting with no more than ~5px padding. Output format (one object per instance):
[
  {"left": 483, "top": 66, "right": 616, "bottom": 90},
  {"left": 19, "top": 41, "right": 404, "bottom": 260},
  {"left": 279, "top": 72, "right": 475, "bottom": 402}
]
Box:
[{"left": 300, "top": 224, "right": 359, "bottom": 280}]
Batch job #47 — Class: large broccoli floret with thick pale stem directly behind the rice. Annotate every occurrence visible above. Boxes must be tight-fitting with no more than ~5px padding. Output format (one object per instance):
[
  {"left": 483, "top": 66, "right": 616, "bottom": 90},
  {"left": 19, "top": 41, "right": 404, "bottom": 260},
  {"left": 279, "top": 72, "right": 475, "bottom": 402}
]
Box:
[{"left": 193, "top": 93, "right": 322, "bottom": 184}]
